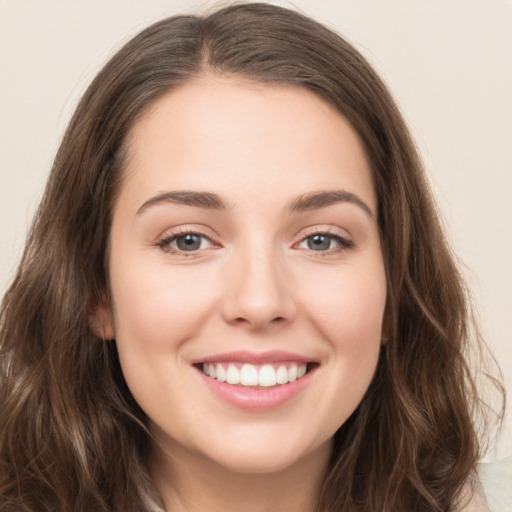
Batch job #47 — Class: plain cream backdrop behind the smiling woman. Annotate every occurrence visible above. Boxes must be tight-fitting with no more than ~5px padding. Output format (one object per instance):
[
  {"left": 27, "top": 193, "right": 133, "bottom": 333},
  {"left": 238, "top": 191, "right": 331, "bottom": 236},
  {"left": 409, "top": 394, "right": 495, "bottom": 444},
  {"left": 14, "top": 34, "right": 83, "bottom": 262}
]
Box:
[{"left": 0, "top": 0, "right": 512, "bottom": 459}]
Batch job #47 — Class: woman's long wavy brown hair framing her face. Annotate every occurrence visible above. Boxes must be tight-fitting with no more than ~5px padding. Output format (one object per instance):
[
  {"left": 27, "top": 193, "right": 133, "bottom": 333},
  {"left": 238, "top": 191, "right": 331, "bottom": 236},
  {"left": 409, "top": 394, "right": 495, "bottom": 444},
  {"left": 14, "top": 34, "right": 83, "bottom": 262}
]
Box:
[{"left": 0, "top": 4, "right": 504, "bottom": 512}]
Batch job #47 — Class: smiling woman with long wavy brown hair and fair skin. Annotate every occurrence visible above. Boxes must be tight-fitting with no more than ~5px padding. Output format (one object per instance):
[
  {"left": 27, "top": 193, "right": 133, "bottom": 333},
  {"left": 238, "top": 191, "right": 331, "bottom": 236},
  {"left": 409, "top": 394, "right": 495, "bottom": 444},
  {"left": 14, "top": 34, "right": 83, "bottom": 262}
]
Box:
[{"left": 0, "top": 4, "right": 500, "bottom": 512}]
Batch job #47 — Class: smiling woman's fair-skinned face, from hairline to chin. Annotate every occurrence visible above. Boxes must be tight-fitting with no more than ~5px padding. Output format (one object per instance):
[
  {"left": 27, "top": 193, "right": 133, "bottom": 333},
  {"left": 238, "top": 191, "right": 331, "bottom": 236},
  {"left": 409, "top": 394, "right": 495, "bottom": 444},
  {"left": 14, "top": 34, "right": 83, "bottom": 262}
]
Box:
[{"left": 98, "top": 77, "right": 386, "bottom": 472}]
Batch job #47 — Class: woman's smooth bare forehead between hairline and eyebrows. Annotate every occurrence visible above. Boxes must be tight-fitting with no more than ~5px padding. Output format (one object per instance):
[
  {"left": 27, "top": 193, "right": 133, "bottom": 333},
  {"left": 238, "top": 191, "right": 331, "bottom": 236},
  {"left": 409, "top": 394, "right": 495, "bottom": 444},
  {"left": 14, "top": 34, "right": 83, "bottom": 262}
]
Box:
[{"left": 121, "top": 76, "right": 376, "bottom": 212}]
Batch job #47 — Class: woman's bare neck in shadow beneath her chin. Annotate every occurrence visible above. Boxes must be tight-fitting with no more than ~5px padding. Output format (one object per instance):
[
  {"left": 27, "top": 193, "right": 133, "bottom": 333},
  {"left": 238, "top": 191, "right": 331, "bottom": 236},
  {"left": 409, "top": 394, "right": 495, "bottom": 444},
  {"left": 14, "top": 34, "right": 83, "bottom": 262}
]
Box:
[{"left": 150, "top": 443, "right": 331, "bottom": 512}]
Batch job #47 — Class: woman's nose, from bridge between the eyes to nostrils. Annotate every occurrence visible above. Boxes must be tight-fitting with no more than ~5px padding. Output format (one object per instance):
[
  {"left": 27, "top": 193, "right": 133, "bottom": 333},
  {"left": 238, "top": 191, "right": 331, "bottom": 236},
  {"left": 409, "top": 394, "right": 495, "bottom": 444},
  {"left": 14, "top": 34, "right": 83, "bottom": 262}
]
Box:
[{"left": 222, "top": 246, "right": 297, "bottom": 331}]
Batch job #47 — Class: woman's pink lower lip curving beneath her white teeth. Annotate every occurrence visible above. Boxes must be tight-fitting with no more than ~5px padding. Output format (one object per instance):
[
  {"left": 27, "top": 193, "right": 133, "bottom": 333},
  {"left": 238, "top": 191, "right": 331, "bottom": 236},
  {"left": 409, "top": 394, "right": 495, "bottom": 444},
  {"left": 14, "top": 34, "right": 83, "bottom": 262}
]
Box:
[{"left": 198, "top": 368, "right": 316, "bottom": 412}]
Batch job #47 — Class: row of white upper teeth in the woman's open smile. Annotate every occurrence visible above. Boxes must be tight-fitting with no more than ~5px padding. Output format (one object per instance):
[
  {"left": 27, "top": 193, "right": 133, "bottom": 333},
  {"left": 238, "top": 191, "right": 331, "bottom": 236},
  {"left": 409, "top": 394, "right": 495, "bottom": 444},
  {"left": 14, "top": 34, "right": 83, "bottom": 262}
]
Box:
[{"left": 203, "top": 363, "right": 307, "bottom": 388}]
